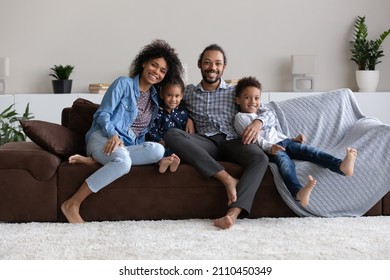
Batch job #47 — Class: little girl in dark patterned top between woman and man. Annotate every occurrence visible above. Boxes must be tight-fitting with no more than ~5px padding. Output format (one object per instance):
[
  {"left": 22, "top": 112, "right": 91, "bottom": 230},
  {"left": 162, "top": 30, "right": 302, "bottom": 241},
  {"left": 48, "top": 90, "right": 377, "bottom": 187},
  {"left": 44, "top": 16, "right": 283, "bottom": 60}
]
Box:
[{"left": 147, "top": 77, "right": 188, "bottom": 173}]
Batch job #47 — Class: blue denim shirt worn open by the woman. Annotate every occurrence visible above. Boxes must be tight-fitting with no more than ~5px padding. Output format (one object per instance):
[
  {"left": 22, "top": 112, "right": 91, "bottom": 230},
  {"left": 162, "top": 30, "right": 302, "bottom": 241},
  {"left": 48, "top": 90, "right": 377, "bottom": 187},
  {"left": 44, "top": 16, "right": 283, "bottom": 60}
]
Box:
[{"left": 85, "top": 75, "right": 158, "bottom": 146}]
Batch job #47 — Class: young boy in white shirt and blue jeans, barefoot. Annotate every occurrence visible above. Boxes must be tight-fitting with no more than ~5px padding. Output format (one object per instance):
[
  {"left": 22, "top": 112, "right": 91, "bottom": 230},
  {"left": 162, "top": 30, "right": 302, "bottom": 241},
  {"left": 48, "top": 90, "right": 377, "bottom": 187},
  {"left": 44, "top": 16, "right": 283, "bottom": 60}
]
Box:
[{"left": 234, "top": 77, "right": 357, "bottom": 207}]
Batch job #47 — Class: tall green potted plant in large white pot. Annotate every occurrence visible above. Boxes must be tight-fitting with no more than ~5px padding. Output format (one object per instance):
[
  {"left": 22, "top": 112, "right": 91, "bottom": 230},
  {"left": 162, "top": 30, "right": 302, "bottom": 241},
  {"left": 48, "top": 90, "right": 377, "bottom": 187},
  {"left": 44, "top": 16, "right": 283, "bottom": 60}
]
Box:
[{"left": 350, "top": 16, "right": 390, "bottom": 91}]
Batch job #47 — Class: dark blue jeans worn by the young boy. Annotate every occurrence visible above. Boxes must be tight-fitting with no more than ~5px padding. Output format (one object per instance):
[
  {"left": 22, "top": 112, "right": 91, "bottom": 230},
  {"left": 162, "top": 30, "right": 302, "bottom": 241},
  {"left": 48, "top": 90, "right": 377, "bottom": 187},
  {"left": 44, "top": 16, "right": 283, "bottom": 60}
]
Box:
[{"left": 269, "top": 139, "right": 344, "bottom": 198}]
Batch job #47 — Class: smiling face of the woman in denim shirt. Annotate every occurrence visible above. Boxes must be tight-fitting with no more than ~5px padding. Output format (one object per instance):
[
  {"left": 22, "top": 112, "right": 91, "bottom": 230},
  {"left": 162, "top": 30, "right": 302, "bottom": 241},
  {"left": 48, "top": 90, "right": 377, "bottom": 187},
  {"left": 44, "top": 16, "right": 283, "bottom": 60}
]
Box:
[{"left": 141, "top": 57, "right": 168, "bottom": 85}]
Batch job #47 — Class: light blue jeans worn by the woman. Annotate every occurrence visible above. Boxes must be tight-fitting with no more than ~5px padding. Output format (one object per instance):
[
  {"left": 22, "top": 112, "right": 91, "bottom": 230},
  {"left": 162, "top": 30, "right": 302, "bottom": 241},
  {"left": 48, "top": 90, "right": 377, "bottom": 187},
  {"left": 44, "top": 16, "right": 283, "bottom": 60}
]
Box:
[{"left": 85, "top": 130, "right": 165, "bottom": 193}]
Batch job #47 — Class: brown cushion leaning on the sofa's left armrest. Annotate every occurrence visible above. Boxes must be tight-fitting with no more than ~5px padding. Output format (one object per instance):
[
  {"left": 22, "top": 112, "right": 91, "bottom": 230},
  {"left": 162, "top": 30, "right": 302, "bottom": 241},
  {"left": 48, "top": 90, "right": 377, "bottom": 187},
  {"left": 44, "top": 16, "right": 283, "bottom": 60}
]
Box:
[{"left": 20, "top": 120, "right": 84, "bottom": 157}]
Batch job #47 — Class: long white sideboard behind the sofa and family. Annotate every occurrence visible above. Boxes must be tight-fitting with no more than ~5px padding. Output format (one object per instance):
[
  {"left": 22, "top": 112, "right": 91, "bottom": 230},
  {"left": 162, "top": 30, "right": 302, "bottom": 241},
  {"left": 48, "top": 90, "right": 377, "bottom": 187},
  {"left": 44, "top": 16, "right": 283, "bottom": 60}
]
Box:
[{"left": 0, "top": 92, "right": 390, "bottom": 124}]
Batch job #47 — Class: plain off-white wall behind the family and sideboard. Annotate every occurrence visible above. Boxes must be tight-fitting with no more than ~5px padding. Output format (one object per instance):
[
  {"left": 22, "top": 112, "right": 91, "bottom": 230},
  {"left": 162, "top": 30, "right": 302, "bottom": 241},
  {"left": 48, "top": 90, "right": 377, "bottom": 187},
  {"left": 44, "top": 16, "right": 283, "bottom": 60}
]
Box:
[{"left": 0, "top": 0, "right": 390, "bottom": 93}]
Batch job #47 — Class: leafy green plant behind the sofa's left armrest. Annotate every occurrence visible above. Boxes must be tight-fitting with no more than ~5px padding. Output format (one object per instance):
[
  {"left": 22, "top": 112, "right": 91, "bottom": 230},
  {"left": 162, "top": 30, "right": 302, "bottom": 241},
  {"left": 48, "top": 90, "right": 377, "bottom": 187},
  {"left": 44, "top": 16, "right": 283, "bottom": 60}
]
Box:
[{"left": 0, "top": 103, "right": 34, "bottom": 145}]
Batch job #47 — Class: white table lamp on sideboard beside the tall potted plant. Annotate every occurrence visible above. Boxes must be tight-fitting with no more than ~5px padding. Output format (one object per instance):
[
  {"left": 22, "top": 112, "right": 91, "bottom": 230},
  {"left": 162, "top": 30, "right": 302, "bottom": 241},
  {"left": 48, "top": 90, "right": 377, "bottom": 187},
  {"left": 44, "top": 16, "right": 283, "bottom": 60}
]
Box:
[{"left": 291, "top": 55, "right": 318, "bottom": 91}]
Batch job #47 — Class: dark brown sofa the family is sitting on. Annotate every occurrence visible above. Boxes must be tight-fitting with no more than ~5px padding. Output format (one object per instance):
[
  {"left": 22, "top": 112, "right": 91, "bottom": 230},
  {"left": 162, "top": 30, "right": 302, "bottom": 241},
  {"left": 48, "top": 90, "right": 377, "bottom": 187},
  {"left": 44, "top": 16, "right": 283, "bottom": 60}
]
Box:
[{"left": 0, "top": 99, "right": 390, "bottom": 222}]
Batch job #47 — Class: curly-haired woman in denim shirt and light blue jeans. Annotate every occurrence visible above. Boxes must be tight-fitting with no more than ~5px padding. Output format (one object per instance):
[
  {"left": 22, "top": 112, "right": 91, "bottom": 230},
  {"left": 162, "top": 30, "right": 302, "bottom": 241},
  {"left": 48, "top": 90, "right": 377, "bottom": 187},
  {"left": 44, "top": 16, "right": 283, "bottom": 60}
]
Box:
[{"left": 61, "top": 40, "right": 183, "bottom": 223}]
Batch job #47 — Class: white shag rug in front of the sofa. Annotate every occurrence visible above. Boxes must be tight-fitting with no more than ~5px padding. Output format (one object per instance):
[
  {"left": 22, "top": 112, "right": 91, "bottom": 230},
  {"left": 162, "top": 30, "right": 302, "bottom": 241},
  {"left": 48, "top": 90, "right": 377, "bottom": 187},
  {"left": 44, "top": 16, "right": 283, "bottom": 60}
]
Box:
[{"left": 0, "top": 216, "right": 390, "bottom": 260}]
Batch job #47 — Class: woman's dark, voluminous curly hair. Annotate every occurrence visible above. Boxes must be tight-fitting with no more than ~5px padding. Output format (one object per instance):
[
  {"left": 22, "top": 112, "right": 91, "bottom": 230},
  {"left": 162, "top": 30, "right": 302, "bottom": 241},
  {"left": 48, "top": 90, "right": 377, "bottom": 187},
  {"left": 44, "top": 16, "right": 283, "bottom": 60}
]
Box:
[{"left": 129, "top": 40, "right": 184, "bottom": 84}]
